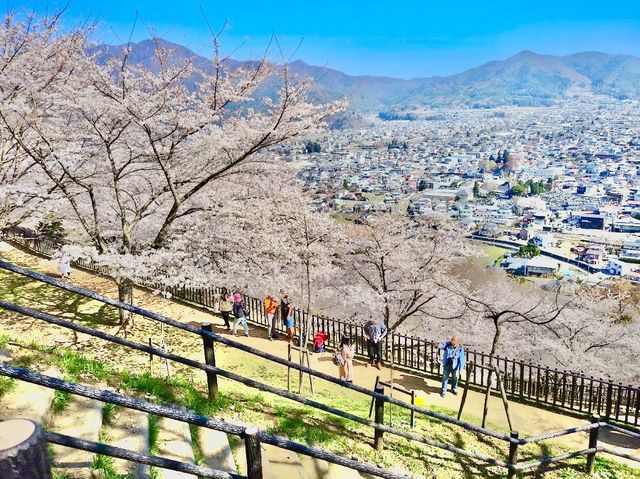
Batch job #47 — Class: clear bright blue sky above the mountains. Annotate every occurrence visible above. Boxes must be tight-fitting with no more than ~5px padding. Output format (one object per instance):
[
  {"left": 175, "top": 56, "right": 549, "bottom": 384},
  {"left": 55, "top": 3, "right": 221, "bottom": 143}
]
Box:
[{"left": 5, "top": 0, "right": 640, "bottom": 78}]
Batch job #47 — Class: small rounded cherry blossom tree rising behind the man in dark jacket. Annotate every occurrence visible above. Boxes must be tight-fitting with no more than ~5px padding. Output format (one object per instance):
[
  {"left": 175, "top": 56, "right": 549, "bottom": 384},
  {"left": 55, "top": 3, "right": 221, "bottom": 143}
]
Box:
[{"left": 343, "top": 213, "right": 467, "bottom": 331}]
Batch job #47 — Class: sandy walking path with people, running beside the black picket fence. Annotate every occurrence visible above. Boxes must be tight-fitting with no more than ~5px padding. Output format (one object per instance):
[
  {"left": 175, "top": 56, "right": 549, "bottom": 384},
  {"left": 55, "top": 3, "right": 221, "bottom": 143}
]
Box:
[{"left": 0, "top": 244, "right": 640, "bottom": 467}]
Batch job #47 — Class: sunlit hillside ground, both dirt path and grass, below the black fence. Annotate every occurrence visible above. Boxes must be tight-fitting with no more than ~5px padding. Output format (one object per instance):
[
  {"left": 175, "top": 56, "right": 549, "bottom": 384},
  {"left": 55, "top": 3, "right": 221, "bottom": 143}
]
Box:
[{"left": 0, "top": 249, "right": 638, "bottom": 479}]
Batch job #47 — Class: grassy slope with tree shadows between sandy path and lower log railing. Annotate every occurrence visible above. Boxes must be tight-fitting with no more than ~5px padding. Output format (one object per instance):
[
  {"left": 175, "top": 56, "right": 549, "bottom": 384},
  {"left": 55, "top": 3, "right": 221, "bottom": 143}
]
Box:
[{"left": 0, "top": 264, "right": 640, "bottom": 478}]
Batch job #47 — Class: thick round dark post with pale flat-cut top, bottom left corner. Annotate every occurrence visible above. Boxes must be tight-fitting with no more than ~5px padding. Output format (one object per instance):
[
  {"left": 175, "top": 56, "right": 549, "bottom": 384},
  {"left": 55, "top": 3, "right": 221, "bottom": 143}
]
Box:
[{"left": 0, "top": 419, "right": 51, "bottom": 479}]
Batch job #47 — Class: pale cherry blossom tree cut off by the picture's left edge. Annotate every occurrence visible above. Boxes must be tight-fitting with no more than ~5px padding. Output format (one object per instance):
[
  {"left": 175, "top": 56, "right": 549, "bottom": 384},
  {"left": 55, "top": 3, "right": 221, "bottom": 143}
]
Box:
[{"left": 0, "top": 12, "right": 84, "bottom": 229}]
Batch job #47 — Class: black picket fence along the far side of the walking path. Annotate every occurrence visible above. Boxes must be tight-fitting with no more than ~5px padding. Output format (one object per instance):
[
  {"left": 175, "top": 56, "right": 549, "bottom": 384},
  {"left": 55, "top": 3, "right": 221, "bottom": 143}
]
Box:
[{"left": 5, "top": 228, "right": 640, "bottom": 426}]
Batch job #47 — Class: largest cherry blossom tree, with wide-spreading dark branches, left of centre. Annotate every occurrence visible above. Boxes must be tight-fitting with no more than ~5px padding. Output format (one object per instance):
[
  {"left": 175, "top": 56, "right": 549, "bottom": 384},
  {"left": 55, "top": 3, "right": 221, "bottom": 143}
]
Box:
[{"left": 0, "top": 15, "right": 344, "bottom": 330}]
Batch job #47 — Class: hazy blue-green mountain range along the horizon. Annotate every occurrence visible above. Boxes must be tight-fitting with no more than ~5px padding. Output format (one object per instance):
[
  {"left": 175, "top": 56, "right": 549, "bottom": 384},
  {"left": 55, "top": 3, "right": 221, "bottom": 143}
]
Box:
[{"left": 92, "top": 39, "right": 640, "bottom": 112}]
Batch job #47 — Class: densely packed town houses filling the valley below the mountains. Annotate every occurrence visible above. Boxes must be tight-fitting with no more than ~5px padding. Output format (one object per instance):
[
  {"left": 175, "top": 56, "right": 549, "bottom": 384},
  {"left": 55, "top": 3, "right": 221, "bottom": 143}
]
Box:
[{"left": 280, "top": 102, "right": 640, "bottom": 277}]
